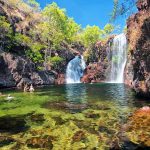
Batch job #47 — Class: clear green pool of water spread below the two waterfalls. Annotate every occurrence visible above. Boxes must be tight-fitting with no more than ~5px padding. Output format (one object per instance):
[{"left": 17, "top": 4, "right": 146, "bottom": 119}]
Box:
[{"left": 0, "top": 83, "right": 150, "bottom": 150}]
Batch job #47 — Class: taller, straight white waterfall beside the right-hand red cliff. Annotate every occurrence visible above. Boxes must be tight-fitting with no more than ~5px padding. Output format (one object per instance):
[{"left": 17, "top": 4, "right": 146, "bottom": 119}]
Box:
[{"left": 110, "top": 33, "right": 127, "bottom": 83}]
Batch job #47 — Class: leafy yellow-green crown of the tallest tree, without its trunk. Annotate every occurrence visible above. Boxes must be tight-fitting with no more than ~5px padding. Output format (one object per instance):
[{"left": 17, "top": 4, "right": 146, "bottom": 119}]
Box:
[{"left": 40, "top": 3, "right": 67, "bottom": 48}]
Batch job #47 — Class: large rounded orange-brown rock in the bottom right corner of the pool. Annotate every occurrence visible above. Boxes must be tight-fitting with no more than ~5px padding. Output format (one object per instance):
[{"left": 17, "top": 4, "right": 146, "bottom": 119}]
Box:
[{"left": 126, "top": 107, "right": 150, "bottom": 147}]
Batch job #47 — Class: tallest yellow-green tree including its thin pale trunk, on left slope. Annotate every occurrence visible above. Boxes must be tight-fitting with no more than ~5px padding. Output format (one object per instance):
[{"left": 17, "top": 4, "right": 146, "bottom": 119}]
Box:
[{"left": 35, "top": 3, "right": 66, "bottom": 69}]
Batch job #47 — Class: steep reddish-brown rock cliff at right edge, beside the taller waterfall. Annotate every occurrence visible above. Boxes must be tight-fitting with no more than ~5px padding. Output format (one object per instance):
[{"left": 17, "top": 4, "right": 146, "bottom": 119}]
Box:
[{"left": 125, "top": 0, "right": 150, "bottom": 97}]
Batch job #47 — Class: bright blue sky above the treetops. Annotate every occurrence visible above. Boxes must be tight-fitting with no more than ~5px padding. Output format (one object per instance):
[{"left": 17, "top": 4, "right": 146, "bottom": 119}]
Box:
[{"left": 37, "top": 0, "right": 137, "bottom": 30}]
